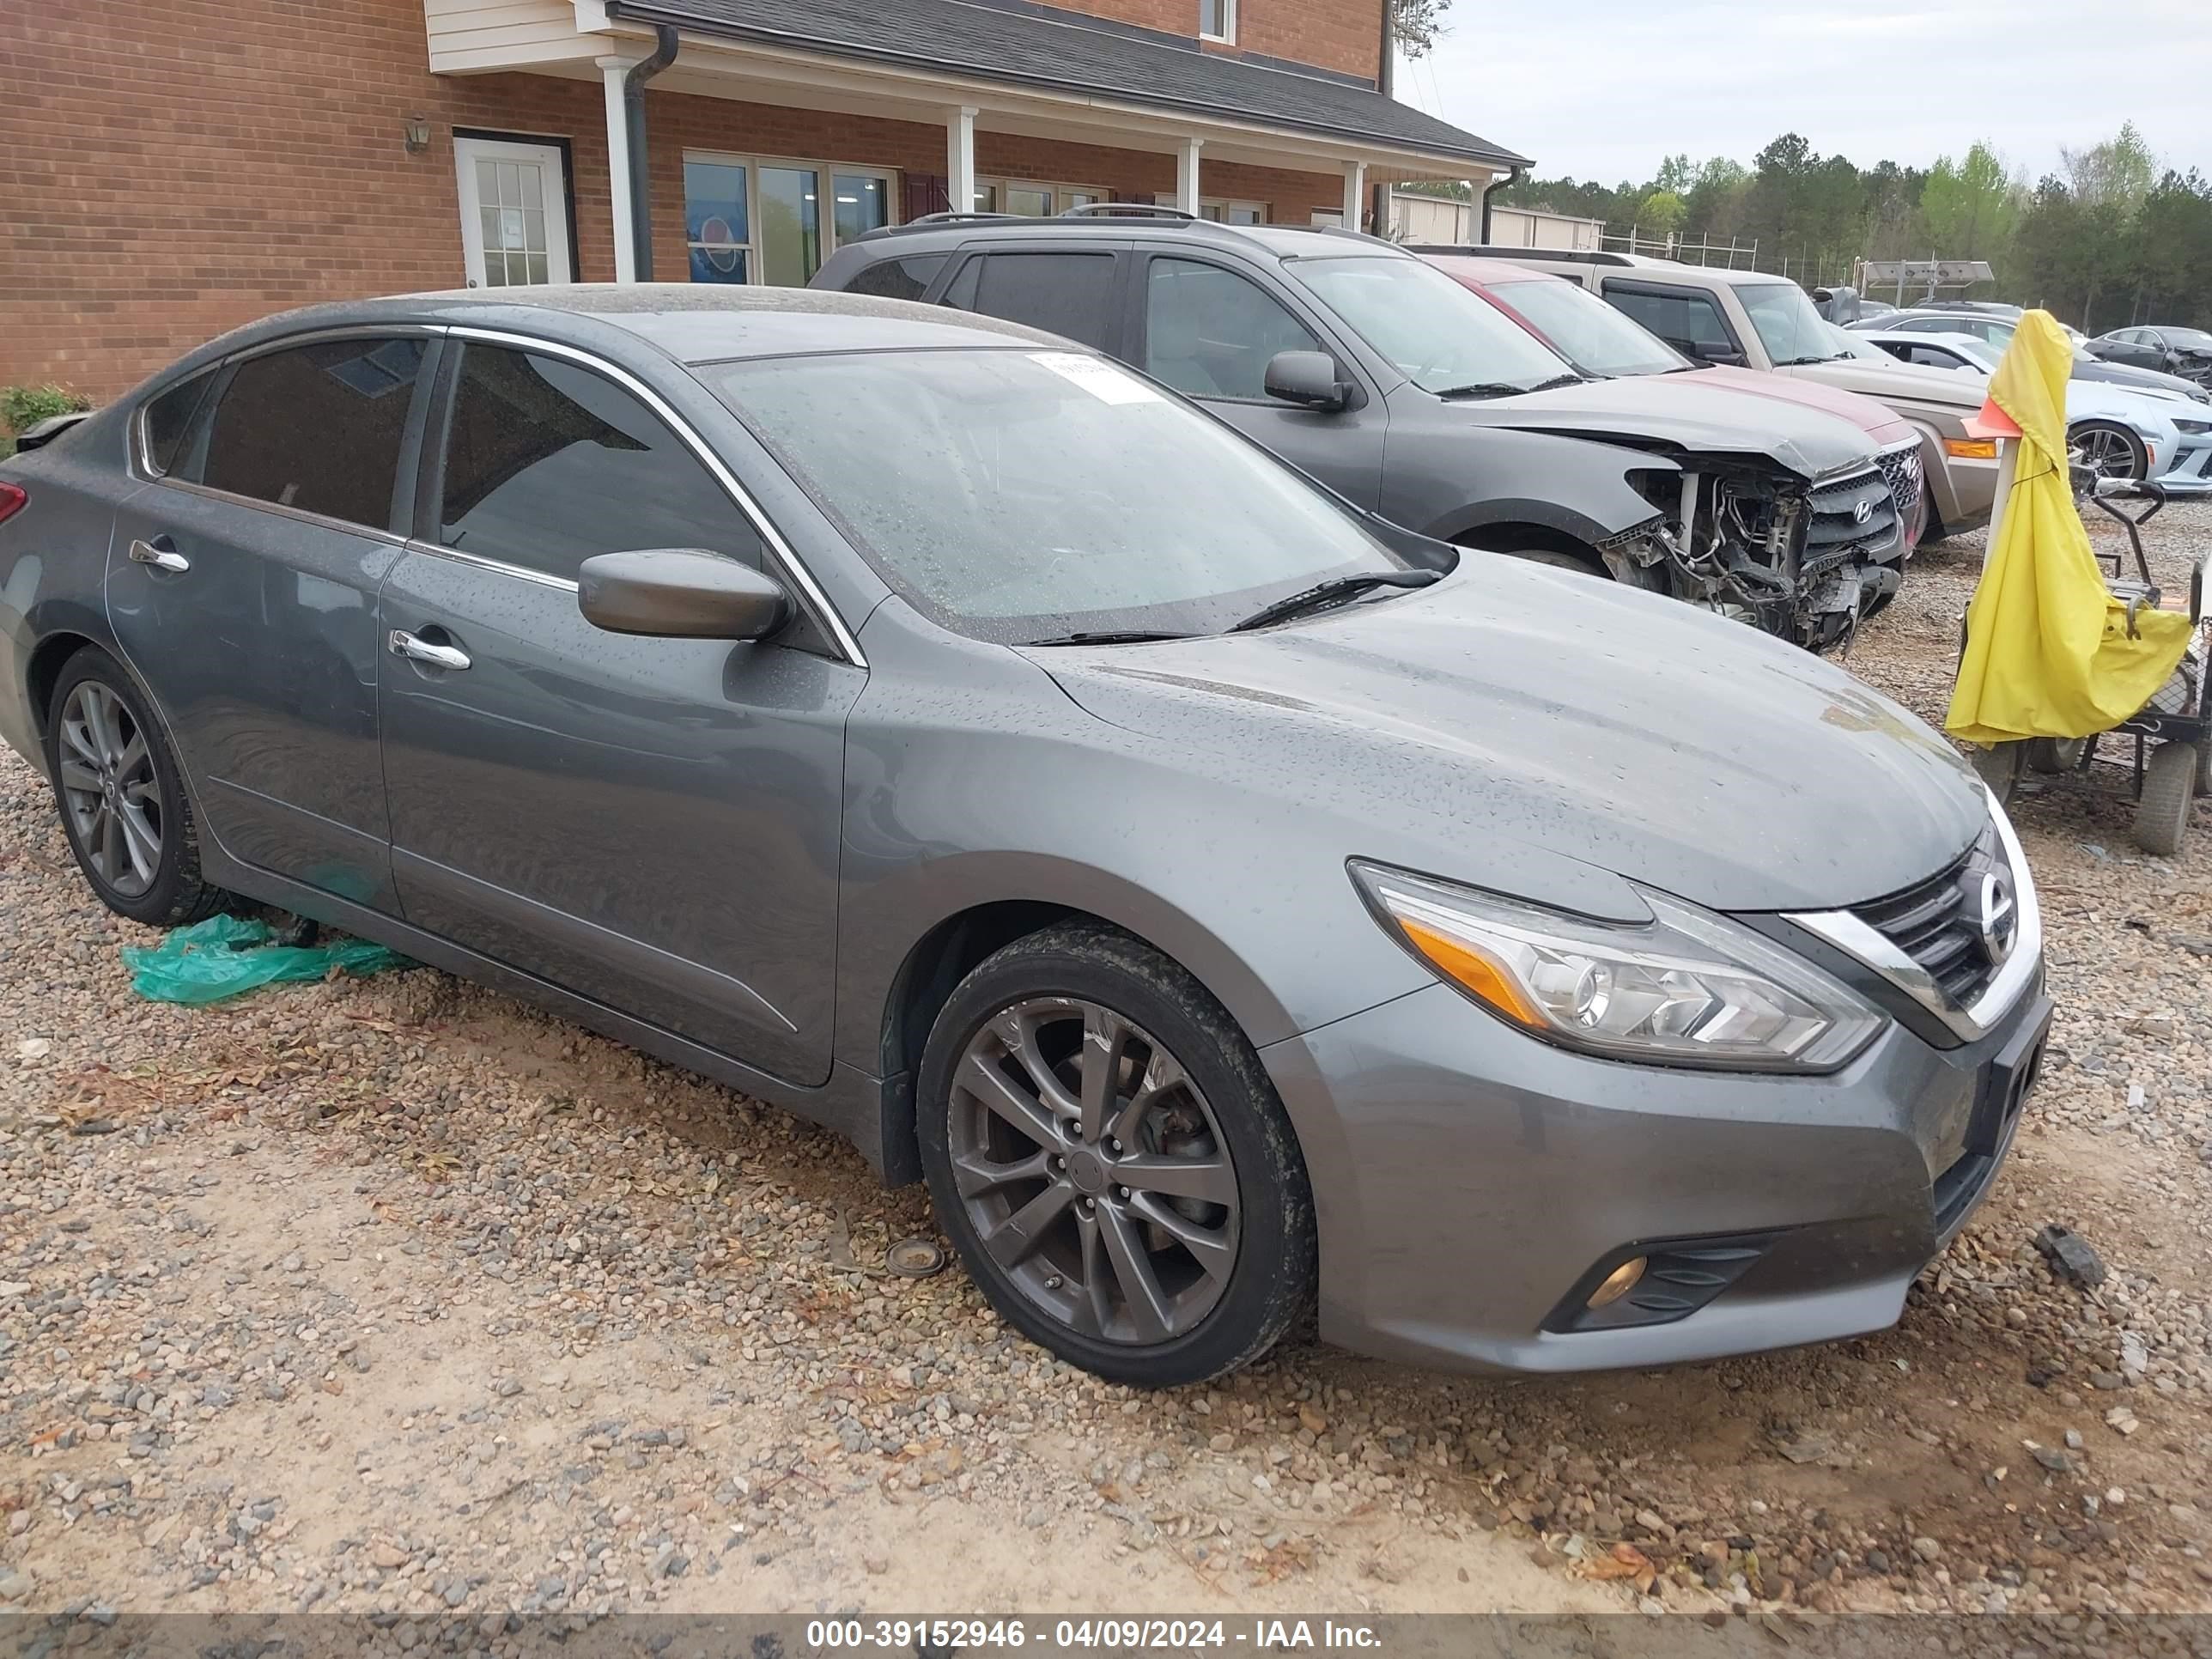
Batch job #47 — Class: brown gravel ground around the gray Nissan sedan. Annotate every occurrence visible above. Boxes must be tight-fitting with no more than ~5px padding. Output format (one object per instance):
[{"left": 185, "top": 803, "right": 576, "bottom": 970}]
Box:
[{"left": 0, "top": 504, "right": 2212, "bottom": 1632}]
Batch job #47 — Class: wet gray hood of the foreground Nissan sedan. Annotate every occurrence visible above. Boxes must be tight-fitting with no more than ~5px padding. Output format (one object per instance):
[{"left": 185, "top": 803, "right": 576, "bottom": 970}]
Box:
[{"left": 1029, "top": 553, "right": 1986, "bottom": 911}]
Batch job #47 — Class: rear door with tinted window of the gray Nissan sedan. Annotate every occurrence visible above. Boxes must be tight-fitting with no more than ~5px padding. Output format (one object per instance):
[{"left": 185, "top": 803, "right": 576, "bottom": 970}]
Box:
[{"left": 108, "top": 330, "right": 438, "bottom": 909}]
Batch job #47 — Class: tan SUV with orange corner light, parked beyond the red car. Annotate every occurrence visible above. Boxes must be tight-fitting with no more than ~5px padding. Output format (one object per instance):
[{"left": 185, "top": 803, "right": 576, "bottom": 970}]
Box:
[{"left": 1422, "top": 248, "right": 1997, "bottom": 542}]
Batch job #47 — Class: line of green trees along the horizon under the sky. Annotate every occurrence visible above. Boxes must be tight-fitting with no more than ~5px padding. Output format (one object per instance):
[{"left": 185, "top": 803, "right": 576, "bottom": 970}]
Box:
[{"left": 1444, "top": 124, "right": 2212, "bottom": 334}]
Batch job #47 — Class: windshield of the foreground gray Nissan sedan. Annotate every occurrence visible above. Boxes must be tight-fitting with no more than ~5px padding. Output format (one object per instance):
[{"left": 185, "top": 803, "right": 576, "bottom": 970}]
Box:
[{"left": 702, "top": 349, "right": 1409, "bottom": 644}]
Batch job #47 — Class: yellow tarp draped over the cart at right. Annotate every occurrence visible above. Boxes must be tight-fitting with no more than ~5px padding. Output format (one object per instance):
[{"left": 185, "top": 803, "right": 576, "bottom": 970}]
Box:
[{"left": 1944, "top": 312, "right": 2190, "bottom": 744}]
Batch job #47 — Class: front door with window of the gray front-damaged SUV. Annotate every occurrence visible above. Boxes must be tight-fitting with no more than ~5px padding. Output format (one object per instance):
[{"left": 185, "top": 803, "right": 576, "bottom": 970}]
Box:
[{"left": 1128, "top": 250, "right": 1389, "bottom": 508}]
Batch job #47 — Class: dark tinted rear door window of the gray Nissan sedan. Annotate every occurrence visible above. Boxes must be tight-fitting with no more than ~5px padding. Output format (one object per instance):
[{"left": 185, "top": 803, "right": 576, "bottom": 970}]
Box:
[{"left": 179, "top": 338, "right": 422, "bottom": 531}]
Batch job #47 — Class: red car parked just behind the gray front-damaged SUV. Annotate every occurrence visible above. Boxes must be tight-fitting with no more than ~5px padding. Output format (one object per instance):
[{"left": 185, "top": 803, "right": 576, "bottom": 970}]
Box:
[{"left": 1422, "top": 254, "right": 1924, "bottom": 553}]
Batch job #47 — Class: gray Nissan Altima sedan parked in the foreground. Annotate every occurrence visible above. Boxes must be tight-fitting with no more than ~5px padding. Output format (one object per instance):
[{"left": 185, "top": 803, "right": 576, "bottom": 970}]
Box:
[{"left": 0, "top": 288, "right": 2051, "bottom": 1385}]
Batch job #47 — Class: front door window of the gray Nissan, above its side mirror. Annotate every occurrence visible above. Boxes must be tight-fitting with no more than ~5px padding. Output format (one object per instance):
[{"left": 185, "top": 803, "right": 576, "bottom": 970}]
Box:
[{"left": 438, "top": 345, "right": 761, "bottom": 581}]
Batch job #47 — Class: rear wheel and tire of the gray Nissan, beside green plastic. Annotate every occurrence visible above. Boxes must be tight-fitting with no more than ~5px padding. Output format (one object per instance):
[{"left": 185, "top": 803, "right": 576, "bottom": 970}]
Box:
[{"left": 46, "top": 646, "right": 226, "bottom": 927}]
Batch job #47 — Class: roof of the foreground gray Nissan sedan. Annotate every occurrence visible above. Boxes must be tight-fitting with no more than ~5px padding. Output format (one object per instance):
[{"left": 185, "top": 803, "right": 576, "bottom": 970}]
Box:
[{"left": 174, "top": 283, "right": 1078, "bottom": 374}]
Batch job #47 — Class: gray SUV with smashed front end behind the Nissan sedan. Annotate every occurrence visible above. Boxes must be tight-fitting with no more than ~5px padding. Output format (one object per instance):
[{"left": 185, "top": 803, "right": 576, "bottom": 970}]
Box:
[{"left": 814, "top": 224, "right": 1909, "bottom": 648}]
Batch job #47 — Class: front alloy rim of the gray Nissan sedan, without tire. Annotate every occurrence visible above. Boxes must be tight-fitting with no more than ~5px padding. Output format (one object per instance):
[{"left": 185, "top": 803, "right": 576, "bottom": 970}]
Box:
[{"left": 947, "top": 998, "right": 1241, "bottom": 1345}]
